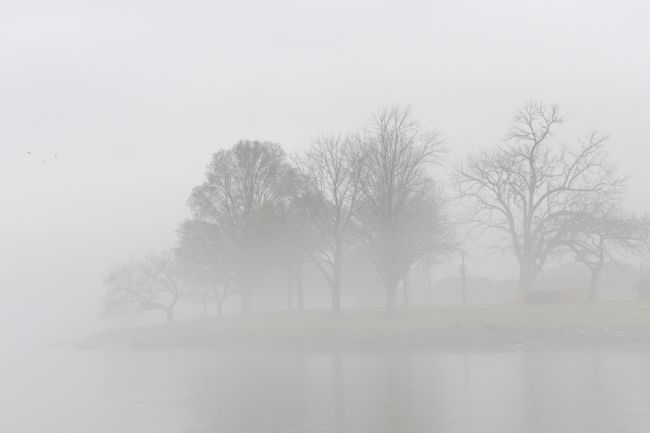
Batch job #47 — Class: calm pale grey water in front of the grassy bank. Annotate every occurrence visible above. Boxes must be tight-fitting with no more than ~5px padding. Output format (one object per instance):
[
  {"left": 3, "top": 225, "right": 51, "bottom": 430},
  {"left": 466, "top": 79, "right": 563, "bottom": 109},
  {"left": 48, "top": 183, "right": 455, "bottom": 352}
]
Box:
[{"left": 0, "top": 348, "right": 650, "bottom": 433}]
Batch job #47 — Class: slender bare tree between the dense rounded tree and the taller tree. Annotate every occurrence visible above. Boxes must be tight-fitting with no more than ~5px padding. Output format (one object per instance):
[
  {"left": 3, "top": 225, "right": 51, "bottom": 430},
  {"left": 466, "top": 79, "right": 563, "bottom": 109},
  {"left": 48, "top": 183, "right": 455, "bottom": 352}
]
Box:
[{"left": 295, "top": 136, "right": 361, "bottom": 316}]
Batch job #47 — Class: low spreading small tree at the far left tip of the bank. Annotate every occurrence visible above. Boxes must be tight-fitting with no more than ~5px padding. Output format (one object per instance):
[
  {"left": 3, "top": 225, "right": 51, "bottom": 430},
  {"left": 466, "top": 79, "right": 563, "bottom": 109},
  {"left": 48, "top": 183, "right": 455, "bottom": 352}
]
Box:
[{"left": 106, "top": 250, "right": 182, "bottom": 323}]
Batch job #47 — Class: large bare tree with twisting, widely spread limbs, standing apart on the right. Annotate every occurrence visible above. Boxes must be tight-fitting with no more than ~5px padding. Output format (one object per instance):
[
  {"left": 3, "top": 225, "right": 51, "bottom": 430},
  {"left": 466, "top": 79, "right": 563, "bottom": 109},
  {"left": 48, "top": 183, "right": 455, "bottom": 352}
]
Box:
[{"left": 456, "top": 103, "right": 625, "bottom": 296}]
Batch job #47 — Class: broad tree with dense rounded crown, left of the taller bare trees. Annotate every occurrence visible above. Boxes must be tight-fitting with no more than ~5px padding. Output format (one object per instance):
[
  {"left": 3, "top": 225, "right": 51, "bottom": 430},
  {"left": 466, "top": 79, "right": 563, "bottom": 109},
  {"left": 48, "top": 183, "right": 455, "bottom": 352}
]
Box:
[{"left": 189, "top": 141, "right": 296, "bottom": 312}]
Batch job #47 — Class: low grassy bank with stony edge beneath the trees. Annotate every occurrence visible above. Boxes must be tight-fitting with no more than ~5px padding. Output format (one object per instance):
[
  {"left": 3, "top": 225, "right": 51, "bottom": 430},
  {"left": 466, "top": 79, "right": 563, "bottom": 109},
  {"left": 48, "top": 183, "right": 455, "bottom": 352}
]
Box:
[{"left": 79, "top": 303, "right": 650, "bottom": 348}]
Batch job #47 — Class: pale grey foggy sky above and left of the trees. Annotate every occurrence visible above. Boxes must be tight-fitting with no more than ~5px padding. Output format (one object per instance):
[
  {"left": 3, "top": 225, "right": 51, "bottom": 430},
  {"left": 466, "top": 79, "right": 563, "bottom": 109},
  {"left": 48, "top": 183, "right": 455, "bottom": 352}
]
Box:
[{"left": 0, "top": 0, "right": 650, "bottom": 342}]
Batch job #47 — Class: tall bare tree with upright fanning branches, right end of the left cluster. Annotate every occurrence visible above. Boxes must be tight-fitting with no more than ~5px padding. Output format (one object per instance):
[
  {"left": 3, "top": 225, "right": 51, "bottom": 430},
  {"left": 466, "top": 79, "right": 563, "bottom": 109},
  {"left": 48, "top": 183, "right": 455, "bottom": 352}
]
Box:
[{"left": 359, "top": 107, "right": 448, "bottom": 312}]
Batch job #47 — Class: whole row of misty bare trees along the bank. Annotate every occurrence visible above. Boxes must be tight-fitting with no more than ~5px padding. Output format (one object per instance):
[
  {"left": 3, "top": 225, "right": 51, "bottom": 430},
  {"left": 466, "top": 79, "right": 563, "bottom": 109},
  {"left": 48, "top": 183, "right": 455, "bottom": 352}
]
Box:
[{"left": 106, "top": 103, "right": 648, "bottom": 322}]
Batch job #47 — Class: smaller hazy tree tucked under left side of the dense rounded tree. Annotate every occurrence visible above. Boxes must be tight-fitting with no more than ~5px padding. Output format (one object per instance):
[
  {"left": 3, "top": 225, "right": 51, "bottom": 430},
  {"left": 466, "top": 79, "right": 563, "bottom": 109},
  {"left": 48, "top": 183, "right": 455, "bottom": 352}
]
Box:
[{"left": 176, "top": 220, "right": 235, "bottom": 319}]
